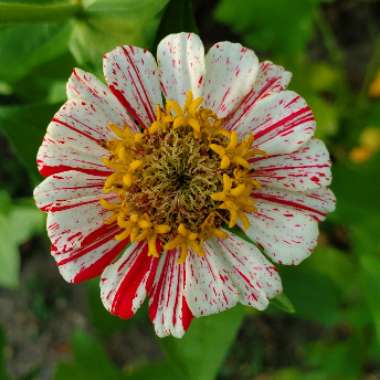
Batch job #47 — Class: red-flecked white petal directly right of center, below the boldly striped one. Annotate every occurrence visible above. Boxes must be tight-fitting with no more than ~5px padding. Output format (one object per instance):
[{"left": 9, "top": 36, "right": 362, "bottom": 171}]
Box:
[{"left": 251, "top": 139, "right": 331, "bottom": 191}]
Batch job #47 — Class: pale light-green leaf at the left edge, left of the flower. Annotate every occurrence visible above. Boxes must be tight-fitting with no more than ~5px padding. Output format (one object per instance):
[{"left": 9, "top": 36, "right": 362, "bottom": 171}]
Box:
[{"left": 0, "top": 196, "right": 44, "bottom": 287}]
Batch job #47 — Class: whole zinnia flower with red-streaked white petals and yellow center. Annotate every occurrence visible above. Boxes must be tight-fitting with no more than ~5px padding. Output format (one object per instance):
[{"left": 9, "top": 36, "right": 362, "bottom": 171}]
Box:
[{"left": 34, "top": 33, "right": 335, "bottom": 337}]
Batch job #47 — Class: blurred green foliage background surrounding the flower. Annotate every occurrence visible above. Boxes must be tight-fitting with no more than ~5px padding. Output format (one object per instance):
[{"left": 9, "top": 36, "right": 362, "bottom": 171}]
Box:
[{"left": 0, "top": 0, "right": 380, "bottom": 380}]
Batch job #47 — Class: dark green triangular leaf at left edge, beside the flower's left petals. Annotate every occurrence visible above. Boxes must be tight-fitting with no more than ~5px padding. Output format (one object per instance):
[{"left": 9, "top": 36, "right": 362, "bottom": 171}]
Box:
[{"left": 0, "top": 104, "right": 58, "bottom": 178}]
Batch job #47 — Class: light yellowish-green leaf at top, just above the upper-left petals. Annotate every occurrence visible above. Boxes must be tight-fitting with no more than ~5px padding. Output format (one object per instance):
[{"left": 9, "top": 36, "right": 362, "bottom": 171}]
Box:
[{"left": 70, "top": 0, "right": 168, "bottom": 68}]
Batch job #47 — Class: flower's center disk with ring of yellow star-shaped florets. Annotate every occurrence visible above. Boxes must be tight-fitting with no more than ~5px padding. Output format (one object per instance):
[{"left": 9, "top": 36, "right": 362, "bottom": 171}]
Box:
[{"left": 100, "top": 91, "right": 265, "bottom": 262}]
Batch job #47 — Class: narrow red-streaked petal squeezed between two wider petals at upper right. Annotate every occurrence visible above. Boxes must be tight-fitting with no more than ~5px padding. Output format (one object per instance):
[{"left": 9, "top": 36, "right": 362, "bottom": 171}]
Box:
[{"left": 225, "top": 61, "right": 292, "bottom": 129}]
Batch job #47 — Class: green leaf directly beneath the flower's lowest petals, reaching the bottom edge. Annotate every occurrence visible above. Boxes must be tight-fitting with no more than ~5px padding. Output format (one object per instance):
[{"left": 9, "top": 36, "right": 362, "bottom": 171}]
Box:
[{"left": 161, "top": 306, "right": 245, "bottom": 380}]
